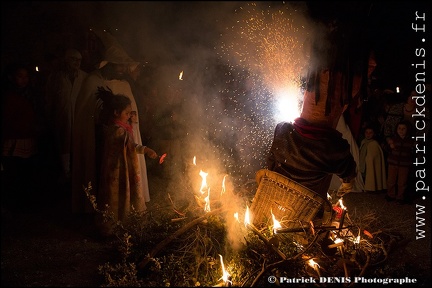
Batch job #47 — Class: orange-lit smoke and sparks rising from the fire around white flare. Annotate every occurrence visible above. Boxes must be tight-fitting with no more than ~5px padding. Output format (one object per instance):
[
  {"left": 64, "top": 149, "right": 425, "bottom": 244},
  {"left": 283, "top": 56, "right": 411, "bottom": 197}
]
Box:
[{"left": 82, "top": 2, "right": 322, "bottom": 249}]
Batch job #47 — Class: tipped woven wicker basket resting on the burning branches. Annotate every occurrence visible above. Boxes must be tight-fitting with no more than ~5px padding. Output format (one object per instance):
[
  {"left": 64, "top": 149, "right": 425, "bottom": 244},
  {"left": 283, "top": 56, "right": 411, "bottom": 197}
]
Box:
[{"left": 250, "top": 169, "right": 332, "bottom": 228}]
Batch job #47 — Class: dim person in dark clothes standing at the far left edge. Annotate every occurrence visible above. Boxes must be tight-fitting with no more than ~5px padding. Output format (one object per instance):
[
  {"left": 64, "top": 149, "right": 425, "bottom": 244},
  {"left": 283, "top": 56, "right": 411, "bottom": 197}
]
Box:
[{"left": 1, "top": 63, "right": 40, "bottom": 206}]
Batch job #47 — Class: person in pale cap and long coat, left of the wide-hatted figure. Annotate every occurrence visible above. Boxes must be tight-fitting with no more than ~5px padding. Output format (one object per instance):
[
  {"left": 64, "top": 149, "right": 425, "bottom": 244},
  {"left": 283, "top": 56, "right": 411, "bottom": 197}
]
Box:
[{"left": 46, "top": 49, "right": 87, "bottom": 182}]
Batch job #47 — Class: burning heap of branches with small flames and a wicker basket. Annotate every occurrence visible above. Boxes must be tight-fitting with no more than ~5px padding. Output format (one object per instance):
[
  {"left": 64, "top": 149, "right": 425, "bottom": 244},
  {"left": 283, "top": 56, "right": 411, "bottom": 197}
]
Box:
[{"left": 85, "top": 158, "right": 398, "bottom": 287}]
